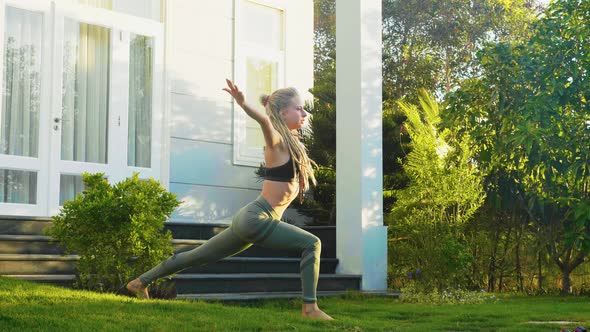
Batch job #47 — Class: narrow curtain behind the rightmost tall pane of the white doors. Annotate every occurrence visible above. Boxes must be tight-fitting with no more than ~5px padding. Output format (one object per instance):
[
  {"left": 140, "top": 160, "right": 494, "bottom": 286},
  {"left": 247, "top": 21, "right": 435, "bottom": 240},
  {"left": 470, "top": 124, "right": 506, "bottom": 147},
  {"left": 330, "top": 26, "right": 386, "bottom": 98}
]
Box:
[{"left": 127, "top": 35, "right": 153, "bottom": 167}]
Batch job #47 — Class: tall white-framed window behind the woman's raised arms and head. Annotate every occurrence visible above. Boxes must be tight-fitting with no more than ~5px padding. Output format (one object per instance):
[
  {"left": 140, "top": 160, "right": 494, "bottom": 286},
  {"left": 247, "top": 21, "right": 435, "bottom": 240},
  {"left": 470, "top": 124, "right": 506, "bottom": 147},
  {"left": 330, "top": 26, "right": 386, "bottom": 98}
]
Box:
[{"left": 234, "top": 1, "right": 285, "bottom": 166}]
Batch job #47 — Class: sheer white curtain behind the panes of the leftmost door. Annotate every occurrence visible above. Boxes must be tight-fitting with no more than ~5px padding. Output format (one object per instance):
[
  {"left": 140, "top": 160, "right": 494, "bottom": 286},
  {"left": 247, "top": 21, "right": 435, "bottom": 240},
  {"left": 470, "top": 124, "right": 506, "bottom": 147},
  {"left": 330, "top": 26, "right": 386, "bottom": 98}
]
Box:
[{"left": 0, "top": 7, "right": 43, "bottom": 204}]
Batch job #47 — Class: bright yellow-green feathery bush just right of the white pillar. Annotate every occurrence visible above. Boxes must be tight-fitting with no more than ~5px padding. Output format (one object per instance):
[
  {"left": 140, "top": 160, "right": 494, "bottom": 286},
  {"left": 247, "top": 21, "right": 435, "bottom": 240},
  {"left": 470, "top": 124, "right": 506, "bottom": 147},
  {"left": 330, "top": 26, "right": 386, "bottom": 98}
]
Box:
[{"left": 384, "top": 90, "right": 485, "bottom": 292}]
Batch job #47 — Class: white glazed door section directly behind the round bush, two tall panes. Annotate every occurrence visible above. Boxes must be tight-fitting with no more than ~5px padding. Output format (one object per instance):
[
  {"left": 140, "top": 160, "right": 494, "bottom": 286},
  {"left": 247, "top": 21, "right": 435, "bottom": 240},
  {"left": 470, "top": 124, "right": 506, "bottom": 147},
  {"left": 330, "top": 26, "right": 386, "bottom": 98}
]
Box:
[{"left": 49, "top": 3, "right": 163, "bottom": 215}]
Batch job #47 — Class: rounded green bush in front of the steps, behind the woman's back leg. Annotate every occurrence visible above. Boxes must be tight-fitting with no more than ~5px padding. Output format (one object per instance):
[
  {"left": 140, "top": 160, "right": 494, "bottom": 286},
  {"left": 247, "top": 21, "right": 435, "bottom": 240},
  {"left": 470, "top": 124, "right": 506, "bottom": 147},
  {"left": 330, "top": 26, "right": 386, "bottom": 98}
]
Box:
[{"left": 46, "top": 173, "right": 182, "bottom": 292}]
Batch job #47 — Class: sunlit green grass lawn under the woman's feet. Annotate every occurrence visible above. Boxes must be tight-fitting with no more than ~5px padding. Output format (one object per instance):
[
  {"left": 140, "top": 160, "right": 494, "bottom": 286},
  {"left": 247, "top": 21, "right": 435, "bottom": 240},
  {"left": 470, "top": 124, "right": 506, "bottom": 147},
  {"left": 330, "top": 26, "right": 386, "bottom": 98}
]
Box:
[{"left": 0, "top": 277, "right": 590, "bottom": 332}]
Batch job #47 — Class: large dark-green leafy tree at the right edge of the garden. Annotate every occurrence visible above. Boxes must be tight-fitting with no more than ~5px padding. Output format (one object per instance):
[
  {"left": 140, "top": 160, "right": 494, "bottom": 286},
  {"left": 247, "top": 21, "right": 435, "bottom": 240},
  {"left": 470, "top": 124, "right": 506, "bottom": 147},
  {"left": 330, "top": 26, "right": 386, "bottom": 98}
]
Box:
[{"left": 446, "top": 0, "right": 590, "bottom": 293}]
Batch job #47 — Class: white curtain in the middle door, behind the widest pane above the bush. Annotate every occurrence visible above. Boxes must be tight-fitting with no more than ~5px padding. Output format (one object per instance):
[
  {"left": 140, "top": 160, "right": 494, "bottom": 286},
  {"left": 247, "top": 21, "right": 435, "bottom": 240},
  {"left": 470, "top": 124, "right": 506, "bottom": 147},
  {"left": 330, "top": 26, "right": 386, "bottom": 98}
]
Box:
[{"left": 60, "top": 19, "right": 110, "bottom": 202}]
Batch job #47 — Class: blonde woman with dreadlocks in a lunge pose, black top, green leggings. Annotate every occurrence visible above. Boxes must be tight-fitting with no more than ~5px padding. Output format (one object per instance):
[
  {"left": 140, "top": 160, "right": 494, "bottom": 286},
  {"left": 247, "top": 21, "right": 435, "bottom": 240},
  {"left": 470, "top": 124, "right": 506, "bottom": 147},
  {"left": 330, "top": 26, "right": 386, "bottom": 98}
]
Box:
[{"left": 127, "top": 79, "right": 333, "bottom": 320}]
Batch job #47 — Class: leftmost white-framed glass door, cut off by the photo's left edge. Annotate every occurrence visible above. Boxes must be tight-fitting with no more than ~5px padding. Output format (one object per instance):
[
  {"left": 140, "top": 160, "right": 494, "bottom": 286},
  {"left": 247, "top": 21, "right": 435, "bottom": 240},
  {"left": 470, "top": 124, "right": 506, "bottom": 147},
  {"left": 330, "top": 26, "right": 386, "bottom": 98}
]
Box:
[{"left": 0, "top": 0, "right": 51, "bottom": 216}]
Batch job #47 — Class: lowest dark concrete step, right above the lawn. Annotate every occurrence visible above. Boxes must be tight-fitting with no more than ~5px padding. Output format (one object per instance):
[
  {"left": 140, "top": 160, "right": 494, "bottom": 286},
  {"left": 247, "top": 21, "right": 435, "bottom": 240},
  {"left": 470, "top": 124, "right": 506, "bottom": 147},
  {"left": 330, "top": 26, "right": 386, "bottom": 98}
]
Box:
[{"left": 5, "top": 273, "right": 361, "bottom": 297}]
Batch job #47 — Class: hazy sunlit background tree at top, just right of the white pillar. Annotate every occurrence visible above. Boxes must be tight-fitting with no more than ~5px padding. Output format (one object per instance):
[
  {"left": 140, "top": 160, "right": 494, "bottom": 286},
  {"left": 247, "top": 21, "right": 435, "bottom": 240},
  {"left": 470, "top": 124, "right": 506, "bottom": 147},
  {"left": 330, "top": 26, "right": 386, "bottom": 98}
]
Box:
[{"left": 383, "top": 0, "right": 539, "bottom": 102}]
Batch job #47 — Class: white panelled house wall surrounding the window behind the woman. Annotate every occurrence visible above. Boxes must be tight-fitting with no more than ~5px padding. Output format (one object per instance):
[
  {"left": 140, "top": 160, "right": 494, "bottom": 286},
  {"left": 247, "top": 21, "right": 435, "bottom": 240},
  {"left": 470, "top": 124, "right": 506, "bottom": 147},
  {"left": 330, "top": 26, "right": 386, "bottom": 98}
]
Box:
[{"left": 165, "top": 0, "right": 313, "bottom": 223}]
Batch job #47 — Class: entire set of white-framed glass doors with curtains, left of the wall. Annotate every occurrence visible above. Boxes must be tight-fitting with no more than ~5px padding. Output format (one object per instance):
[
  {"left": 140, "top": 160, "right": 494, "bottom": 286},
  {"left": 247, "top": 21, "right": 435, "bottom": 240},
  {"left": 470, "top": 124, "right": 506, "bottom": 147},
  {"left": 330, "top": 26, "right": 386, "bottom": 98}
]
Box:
[{"left": 0, "top": 0, "right": 164, "bottom": 216}]
